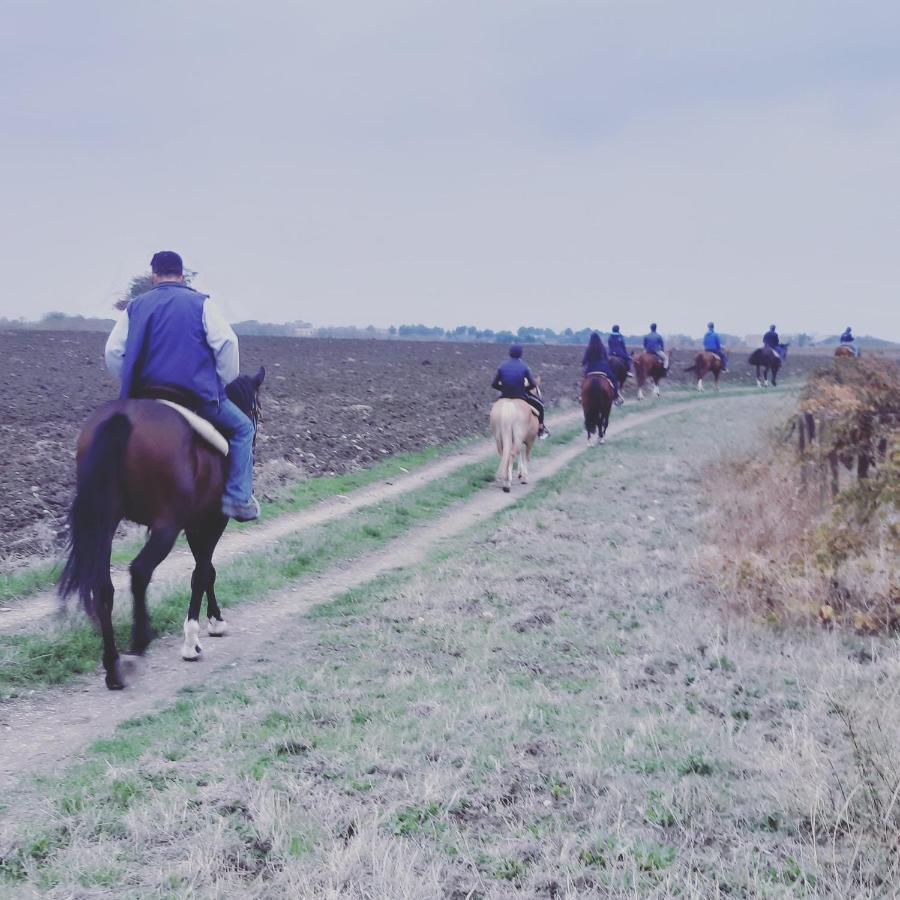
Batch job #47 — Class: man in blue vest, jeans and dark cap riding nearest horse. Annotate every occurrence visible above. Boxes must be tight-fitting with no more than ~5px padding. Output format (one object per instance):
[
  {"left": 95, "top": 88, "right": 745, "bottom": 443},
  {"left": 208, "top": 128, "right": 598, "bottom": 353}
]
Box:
[{"left": 106, "top": 250, "right": 259, "bottom": 522}]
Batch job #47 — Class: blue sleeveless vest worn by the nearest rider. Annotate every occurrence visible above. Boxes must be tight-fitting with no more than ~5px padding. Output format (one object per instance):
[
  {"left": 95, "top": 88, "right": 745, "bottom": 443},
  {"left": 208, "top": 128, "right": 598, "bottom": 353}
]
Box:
[{"left": 119, "top": 282, "right": 221, "bottom": 401}]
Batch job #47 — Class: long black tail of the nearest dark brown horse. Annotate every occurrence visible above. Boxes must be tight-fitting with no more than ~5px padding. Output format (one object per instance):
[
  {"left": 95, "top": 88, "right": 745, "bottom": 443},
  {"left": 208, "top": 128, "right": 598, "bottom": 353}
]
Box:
[{"left": 59, "top": 413, "right": 132, "bottom": 616}]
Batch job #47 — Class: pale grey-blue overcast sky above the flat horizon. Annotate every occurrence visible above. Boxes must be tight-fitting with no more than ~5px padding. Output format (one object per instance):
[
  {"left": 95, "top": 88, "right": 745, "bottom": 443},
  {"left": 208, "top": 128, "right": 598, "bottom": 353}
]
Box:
[{"left": 0, "top": 0, "right": 900, "bottom": 340}]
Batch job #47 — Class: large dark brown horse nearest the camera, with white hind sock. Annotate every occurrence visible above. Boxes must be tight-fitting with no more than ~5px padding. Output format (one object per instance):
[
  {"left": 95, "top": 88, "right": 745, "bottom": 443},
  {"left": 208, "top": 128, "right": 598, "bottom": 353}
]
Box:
[{"left": 59, "top": 368, "right": 266, "bottom": 691}]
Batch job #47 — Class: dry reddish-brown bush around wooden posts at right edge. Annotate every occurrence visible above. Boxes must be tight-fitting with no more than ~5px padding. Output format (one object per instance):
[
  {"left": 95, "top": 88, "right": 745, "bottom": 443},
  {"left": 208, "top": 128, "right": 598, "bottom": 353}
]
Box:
[{"left": 703, "top": 359, "right": 900, "bottom": 632}]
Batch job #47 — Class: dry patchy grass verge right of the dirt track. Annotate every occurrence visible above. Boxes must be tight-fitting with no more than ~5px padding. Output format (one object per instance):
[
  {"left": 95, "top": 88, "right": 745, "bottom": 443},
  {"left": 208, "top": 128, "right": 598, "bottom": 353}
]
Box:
[{"left": 0, "top": 394, "right": 888, "bottom": 900}]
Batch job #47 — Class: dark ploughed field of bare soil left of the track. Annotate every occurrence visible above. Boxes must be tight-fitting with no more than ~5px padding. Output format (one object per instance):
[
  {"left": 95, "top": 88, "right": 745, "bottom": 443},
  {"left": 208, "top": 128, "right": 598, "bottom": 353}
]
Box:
[{"left": 0, "top": 331, "right": 824, "bottom": 567}]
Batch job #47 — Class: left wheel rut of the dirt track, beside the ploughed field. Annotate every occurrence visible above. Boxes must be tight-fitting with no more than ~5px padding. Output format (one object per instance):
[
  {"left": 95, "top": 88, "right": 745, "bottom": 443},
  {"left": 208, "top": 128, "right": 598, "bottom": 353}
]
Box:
[{"left": 0, "top": 409, "right": 582, "bottom": 634}]
